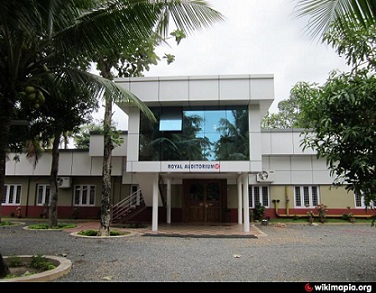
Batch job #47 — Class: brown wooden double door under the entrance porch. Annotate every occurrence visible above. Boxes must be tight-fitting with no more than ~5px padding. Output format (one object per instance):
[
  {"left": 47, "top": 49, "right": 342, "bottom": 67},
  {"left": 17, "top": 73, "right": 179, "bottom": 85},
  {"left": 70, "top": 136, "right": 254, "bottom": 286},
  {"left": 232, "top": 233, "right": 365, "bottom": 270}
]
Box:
[{"left": 183, "top": 179, "right": 227, "bottom": 224}]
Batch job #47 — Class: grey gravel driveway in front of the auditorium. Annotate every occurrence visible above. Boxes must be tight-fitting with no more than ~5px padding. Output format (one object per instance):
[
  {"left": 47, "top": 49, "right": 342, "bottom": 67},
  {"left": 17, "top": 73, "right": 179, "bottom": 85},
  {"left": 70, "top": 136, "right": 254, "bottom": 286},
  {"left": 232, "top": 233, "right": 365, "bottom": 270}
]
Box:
[{"left": 0, "top": 224, "right": 376, "bottom": 283}]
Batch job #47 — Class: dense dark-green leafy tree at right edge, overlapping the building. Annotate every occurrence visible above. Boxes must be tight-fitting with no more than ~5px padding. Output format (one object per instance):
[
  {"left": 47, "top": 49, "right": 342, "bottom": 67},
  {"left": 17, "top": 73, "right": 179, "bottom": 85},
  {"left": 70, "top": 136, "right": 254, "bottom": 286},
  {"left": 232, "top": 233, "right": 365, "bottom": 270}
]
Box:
[{"left": 303, "top": 70, "right": 376, "bottom": 205}]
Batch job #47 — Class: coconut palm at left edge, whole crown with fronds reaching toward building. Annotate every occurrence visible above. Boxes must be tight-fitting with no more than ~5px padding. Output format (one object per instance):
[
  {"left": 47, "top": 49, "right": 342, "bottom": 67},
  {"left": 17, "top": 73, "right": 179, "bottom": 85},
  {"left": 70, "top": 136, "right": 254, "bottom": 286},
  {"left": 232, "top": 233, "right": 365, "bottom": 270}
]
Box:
[{"left": 0, "top": 0, "right": 222, "bottom": 228}]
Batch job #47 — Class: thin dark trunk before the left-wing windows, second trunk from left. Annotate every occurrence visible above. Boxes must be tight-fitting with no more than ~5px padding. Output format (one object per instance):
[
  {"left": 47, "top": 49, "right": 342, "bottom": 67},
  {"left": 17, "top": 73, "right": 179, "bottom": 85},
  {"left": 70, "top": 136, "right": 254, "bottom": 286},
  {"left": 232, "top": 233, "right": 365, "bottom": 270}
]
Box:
[{"left": 48, "top": 132, "right": 61, "bottom": 228}]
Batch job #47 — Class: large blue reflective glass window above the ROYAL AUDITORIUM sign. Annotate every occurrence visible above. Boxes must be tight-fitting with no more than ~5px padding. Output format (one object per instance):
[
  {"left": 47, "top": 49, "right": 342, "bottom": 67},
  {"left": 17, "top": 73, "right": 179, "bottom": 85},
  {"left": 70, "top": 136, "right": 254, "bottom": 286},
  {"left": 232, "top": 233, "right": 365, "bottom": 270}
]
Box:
[{"left": 139, "top": 106, "right": 249, "bottom": 161}]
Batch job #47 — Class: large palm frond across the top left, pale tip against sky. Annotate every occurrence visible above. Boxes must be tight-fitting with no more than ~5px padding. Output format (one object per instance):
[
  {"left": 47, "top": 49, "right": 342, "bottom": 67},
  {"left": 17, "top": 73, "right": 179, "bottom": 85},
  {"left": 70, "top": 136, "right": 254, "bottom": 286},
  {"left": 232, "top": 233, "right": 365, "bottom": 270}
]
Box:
[{"left": 54, "top": 0, "right": 224, "bottom": 61}]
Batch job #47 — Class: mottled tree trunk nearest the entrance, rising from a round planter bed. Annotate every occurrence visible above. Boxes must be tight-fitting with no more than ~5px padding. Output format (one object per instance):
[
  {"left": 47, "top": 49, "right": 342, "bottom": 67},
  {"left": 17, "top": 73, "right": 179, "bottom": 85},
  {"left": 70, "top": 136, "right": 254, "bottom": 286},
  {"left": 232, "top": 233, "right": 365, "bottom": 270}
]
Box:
[{"left": 98, "top": 95, "right": 113, "bottom": 236}]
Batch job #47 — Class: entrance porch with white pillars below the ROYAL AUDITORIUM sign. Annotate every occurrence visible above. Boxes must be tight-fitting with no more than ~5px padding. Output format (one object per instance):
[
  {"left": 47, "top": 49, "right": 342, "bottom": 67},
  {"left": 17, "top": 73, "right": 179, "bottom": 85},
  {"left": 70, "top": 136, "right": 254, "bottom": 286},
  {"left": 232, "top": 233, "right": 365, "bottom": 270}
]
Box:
[{"left": 144, "top": 173, "right": 250, "bottom": 232}]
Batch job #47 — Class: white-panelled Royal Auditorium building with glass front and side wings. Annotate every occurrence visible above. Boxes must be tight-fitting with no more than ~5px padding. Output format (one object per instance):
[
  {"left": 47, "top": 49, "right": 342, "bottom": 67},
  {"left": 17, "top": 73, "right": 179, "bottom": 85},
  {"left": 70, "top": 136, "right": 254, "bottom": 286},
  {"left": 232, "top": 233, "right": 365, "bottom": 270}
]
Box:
[{"left": 2, "top": 75, "right": 370, "bottom": 232}]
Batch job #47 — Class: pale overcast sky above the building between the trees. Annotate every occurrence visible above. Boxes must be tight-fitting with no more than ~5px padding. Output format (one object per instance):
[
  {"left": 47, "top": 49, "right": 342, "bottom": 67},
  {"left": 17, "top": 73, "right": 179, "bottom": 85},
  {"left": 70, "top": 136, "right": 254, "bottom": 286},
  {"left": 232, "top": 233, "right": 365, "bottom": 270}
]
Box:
[{"left": 97, "top": 0, "right": 346, "bottom": 129}]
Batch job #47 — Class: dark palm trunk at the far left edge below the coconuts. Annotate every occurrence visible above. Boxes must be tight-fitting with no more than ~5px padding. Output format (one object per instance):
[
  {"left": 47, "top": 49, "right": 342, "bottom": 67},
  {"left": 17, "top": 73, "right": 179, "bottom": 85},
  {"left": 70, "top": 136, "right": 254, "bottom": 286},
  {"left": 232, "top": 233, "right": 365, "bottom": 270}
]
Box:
[{"left": 0, "top": 97, "right": 12, "bottom": 222}]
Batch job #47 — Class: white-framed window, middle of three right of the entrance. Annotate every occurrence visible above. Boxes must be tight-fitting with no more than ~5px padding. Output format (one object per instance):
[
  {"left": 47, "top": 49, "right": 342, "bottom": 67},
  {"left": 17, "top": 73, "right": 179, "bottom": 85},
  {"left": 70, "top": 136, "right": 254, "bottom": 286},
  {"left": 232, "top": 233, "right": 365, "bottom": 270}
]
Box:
[{"left": 294, "top": 185, "right": 320, "bottom": 209}]
